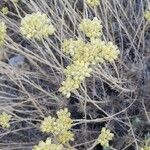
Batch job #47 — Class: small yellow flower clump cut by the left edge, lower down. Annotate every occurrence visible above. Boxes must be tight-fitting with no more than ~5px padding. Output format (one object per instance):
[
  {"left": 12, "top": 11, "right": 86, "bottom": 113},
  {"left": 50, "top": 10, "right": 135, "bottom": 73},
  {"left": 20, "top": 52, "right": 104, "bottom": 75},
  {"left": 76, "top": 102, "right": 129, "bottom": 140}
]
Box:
[{"left": 0, "top": 112, "right": 11, "bottom": 128}]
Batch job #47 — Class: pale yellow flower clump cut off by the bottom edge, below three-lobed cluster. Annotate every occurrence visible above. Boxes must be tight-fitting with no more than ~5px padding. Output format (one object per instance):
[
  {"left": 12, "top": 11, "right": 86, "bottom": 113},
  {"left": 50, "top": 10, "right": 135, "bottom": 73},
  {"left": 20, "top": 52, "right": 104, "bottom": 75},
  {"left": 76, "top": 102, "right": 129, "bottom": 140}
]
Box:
[{"left": 32, "top": 138, "right": 64, "bottom": 150}]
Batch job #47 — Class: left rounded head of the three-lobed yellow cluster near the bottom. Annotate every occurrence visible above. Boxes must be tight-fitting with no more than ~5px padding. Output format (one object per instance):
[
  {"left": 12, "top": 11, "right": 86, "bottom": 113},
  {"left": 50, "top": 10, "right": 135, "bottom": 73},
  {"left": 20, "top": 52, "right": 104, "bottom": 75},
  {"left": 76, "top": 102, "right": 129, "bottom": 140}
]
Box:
[{"left": 40, "top": 116, "right": 56, "bottom": 133}]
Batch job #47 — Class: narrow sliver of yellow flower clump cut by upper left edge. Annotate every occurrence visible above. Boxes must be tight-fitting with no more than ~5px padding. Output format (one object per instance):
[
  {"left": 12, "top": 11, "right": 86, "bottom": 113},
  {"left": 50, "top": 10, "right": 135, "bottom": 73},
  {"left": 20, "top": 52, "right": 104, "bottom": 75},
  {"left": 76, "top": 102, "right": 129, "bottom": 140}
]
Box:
[{"left": 0, "top": 21, "right": 7, "bottom": 47}]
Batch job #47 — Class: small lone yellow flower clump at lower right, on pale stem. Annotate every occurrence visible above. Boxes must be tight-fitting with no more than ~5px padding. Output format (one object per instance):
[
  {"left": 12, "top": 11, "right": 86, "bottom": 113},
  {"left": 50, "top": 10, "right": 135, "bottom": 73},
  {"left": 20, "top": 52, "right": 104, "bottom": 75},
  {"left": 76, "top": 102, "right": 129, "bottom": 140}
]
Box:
[{"left": 98, "top": 128, "right": 114, "bottom": 147}]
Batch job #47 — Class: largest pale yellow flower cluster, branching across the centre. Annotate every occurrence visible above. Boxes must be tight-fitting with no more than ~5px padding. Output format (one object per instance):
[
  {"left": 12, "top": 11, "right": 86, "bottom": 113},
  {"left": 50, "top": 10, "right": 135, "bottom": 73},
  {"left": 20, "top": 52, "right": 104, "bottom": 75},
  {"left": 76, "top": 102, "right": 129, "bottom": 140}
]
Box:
[{"left": 59, "top": 18, "right": 120, "bottom": 98}]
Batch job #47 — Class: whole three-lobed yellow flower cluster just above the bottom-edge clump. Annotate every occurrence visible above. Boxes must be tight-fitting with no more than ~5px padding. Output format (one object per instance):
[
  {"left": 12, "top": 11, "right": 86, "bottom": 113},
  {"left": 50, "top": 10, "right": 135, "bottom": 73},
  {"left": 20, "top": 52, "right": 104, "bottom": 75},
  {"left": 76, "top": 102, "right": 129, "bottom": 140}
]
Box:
[{"left": 40, "top": 108, "right": 74, "bottom": 144}]
